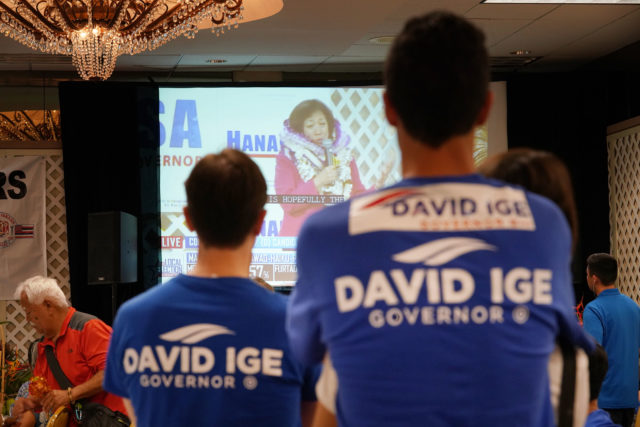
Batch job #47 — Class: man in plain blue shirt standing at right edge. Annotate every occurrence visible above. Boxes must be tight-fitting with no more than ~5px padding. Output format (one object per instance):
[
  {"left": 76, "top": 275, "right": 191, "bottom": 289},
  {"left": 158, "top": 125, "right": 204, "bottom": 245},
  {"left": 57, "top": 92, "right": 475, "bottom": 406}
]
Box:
[{"left": 583, "top": 253, "right": 640, "bottom": 427}]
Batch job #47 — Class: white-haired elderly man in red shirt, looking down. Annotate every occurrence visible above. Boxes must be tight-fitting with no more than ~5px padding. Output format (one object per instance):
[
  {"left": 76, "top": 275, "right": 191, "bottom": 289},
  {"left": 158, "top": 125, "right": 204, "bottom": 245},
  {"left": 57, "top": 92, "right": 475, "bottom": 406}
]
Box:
[{"left": 8, "top": 276, "right": 126, "bottom": 425}]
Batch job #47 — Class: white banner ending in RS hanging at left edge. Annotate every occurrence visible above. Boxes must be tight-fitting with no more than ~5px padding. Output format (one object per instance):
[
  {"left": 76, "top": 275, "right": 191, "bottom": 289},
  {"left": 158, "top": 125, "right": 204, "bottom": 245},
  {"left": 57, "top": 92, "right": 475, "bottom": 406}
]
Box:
[{"left": 0, "top": 156, "right": 47, "bottom": 300}]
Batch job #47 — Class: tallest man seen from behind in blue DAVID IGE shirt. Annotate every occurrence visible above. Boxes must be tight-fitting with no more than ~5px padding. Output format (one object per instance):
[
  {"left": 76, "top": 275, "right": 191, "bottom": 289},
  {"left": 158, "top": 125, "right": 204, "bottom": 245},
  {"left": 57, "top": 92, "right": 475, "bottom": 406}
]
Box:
[{"left": 287, "top": 12, "right": 595, "bottom": 427}]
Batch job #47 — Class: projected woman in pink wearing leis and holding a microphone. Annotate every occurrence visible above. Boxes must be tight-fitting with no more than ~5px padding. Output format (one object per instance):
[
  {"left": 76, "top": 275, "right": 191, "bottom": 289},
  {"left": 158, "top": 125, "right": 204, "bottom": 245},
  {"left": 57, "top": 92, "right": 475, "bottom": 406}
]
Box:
[{"left": 275, "top": 99, "right": 365, "bottom": 236}]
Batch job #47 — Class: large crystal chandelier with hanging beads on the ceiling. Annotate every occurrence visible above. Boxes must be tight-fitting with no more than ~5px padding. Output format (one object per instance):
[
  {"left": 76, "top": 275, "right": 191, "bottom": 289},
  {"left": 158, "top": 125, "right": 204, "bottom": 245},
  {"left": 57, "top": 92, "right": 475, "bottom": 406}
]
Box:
[{"left": 0, "top": 0, "right": 283, "bottom": 80}]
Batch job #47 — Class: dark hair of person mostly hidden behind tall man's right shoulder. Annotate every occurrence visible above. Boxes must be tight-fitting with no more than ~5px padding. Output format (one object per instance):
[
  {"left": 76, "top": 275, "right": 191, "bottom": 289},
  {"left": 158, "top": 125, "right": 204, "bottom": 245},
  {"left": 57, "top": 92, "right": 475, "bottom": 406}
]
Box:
[{"left": 478, "top": 147, "right": 578, "bottom": 252}]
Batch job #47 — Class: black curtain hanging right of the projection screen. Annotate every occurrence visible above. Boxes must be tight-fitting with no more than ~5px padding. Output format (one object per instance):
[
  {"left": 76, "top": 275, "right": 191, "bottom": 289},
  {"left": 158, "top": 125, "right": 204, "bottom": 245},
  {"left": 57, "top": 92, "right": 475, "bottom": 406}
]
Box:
[{"left": 506, "top": 71, "right": 640, "bottom": 303}]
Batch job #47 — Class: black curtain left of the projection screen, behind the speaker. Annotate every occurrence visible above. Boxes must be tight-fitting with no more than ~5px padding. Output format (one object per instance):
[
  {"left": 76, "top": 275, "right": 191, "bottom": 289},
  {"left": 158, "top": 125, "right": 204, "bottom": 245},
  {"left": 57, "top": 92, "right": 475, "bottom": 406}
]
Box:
[{"left": 60, "top": 82, "right": 160, "bottom": 324}]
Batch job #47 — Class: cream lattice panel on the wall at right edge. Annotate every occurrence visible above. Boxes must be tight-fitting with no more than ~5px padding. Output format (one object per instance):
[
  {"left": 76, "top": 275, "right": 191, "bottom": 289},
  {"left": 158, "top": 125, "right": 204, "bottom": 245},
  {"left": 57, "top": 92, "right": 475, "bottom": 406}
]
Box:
[{"left": 607, "top": 127, "right": 640, "bottom": 302}]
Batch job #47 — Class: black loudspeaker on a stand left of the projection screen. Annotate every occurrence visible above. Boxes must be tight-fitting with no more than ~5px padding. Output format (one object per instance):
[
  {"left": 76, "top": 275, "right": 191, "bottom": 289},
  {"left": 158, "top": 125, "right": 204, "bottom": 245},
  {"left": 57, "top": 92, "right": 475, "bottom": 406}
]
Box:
[{"left": 87, "top": 212, "right": 138, "bottom": 285}]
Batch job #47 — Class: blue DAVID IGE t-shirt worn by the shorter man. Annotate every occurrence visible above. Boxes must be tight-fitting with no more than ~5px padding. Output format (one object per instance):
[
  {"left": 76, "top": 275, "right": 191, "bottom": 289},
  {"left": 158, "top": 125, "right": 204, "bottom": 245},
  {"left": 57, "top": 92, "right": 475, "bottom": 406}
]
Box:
[{"left": 104, "top": 275, "right": 319, "bottom": 427}]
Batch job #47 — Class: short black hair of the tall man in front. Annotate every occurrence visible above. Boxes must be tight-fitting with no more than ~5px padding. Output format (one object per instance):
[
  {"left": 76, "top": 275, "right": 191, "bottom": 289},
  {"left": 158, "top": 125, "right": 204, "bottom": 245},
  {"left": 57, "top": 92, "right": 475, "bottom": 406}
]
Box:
[{"left": 384, "top": 11, "right": 489, "bottom": 148}]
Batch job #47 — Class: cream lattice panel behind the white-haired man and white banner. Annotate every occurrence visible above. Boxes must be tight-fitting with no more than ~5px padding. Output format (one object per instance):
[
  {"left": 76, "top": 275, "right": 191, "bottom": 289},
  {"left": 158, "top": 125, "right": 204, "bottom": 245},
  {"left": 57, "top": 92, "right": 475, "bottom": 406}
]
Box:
[{"left": 6, "top": 150, "right": 71, "bottom": 356}]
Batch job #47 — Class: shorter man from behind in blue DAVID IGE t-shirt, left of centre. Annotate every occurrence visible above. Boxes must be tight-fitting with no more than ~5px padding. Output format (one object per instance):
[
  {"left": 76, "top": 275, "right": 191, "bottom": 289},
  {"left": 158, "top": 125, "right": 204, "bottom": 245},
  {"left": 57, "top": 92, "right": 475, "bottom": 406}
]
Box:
[{"left": 104, "top": 149, "right": 318, "bottom": 427}]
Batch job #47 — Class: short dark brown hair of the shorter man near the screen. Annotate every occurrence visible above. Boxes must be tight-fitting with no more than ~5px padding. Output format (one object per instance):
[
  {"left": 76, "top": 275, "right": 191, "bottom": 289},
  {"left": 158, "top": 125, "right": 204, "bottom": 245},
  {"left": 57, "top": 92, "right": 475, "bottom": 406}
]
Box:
[{"left": 185, "top": 148, "right": 267, "bottom": 248}]
